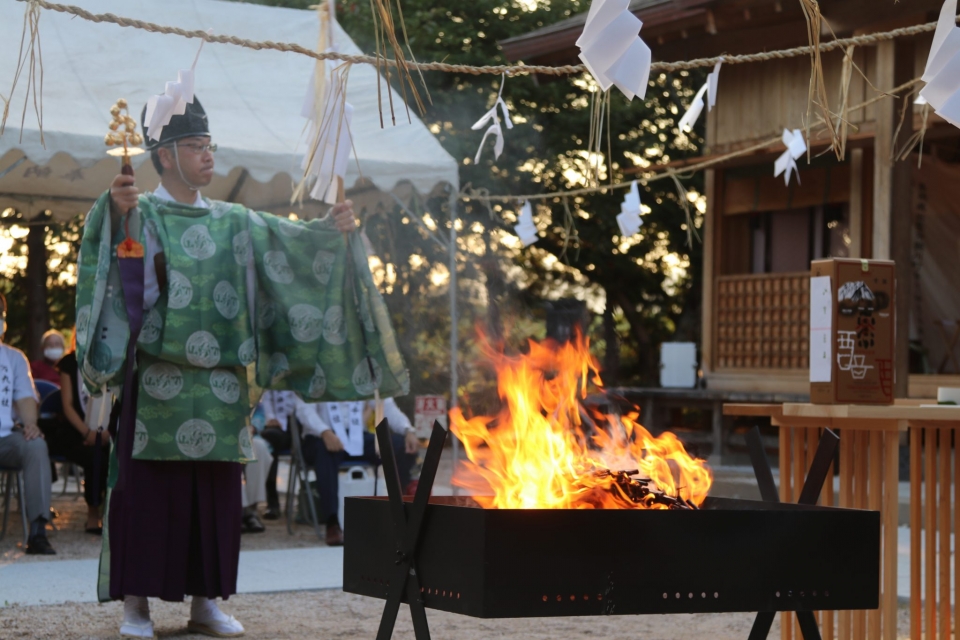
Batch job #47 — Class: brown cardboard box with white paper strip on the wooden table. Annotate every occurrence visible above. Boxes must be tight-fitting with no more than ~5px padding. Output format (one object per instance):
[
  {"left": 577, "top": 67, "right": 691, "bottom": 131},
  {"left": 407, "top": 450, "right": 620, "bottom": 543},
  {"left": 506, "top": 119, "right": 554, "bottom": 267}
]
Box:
[{"left": 810, "top": 258, "right": 896, "bottom": 404}]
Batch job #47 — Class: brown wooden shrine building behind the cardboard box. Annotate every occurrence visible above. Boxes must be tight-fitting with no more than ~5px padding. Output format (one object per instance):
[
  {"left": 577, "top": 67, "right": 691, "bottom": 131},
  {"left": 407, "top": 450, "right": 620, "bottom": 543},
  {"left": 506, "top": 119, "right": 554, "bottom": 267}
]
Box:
[{"left": 501, "top": 0, "right": 960, "bottom": 397}]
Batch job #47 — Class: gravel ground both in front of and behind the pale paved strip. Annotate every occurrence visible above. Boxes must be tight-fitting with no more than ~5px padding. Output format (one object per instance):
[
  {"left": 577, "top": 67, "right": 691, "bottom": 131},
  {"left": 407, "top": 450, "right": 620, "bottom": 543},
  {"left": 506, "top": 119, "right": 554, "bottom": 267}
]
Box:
[{"left": 0, "top": 468, "right": 909, "bottom": 640}]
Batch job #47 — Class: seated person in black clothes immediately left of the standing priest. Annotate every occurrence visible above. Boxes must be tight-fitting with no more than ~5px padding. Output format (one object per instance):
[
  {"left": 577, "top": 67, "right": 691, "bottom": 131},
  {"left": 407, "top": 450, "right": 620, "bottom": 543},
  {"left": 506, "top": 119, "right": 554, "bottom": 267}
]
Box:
[{"left": 52, "top": 332, "right": 110, "bottom": 534}]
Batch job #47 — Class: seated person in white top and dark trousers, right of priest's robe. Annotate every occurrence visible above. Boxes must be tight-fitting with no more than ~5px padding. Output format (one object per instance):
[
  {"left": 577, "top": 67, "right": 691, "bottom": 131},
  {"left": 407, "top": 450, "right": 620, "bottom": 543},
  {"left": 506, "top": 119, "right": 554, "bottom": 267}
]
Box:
[{"left": 297, "top": 398, "right": 420, "bottom": 546}]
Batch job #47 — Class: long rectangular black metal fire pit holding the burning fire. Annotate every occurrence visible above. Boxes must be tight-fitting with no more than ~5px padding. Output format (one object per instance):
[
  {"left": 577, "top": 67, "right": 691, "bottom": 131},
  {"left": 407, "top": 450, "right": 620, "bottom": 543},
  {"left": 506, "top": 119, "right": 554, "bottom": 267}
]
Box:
[{"left": 343, "top": 425, "right": 880, "bottom": 640}]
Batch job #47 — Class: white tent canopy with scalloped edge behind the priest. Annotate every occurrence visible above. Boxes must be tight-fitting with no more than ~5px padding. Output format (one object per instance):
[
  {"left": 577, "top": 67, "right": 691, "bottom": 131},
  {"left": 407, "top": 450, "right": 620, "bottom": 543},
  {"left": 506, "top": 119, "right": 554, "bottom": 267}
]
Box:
[{"left": 0, "top": 0, "right": 458, "bottom": 219}]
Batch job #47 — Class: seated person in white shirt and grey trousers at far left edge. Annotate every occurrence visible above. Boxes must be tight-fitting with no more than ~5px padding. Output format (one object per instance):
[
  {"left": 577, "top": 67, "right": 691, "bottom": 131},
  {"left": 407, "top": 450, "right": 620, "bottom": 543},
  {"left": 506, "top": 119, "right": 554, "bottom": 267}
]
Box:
[{"left": 0, "top": 294, "right": 56, "bottom": 555}]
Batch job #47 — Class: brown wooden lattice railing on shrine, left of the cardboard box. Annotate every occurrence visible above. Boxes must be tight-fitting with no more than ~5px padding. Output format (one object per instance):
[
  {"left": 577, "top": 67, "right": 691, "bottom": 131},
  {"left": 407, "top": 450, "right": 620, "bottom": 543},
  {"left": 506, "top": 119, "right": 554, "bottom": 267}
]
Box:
[{"left": 714, "top": 271, "right": 810, "bottom": 369}]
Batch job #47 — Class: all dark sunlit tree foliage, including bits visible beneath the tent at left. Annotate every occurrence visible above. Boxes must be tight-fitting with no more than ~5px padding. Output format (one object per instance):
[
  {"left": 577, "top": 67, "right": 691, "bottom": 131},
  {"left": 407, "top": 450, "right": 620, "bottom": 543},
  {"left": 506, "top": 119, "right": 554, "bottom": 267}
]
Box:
[{"left": 4, "top": 0, "right": 702, "bottom": 407}]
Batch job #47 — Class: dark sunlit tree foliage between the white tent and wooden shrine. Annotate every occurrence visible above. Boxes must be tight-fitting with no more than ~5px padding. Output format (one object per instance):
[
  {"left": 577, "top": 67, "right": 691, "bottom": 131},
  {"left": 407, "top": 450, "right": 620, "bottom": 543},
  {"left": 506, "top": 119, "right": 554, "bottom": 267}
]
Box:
[{"left": 326, "top": 0, "right": 701, "bottom": 383}]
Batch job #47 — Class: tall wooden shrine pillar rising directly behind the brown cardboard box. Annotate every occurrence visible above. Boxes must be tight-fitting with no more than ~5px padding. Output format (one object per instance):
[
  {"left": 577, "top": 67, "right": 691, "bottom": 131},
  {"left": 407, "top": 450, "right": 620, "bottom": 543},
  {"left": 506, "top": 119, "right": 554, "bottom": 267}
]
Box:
[{"left": 873, "top": 38, "right": 914, "bottom": 398}]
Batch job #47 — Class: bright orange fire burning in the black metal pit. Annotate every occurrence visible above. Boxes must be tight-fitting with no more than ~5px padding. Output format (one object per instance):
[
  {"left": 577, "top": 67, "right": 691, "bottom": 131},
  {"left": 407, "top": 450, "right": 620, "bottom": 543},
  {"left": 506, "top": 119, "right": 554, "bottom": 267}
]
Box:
[{"left": 450, "top": 338, "right": 713, "bottom": 509}]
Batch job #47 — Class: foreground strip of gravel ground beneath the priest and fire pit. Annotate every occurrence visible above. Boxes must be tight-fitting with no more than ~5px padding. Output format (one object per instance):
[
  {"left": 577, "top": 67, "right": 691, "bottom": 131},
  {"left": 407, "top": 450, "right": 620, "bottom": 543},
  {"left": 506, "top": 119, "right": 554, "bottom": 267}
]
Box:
[{"left": 0, "top": 591, "right": 908, "bottom": 640}]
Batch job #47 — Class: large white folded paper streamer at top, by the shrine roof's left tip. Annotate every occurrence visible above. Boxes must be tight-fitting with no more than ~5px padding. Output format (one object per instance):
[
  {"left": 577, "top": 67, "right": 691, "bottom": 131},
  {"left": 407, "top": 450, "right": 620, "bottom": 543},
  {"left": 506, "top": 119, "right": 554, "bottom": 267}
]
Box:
[{"left": 577, "top": 0, "right": 652, "bottom": 100}]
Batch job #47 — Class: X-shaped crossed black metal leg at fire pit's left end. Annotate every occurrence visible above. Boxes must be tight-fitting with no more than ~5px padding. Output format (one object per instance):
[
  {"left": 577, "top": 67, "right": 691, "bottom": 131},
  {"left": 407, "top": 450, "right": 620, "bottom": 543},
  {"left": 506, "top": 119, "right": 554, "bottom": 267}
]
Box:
[{"left": 377, "top": 420, "right": 447, "bottom": 640}]
